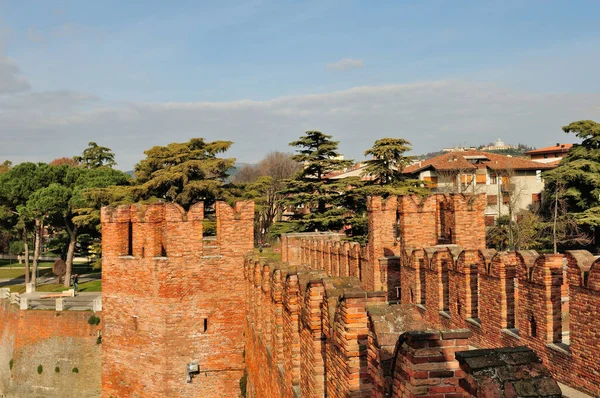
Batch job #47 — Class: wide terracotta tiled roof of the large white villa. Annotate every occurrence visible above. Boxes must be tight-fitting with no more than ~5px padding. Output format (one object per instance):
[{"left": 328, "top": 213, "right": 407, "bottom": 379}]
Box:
[{"left": 403, "top": 151, "right": 555, "bottom": 174}]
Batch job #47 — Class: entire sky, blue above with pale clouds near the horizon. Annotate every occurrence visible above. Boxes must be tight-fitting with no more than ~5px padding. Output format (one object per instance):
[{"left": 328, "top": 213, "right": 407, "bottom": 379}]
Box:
[{"left": 0, "top": 0, "right": 600, "bottom": 170}]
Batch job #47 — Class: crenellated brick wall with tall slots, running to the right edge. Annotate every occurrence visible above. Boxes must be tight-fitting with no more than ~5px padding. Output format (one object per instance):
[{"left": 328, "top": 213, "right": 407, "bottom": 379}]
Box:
[{"left": 401, "top": 247, "right": 600, "bottom": 395}]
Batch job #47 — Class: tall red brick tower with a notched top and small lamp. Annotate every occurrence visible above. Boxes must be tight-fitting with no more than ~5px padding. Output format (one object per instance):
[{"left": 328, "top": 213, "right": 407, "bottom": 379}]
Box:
[{"left": 102, "top": 202, "right": 254, "bottom": 398}]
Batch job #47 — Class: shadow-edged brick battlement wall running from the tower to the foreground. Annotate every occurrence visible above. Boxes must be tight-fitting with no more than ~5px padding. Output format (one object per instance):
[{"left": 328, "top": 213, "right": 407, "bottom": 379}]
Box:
[{"left": 244, "top": 253, "right": 482, "bottom": 398}]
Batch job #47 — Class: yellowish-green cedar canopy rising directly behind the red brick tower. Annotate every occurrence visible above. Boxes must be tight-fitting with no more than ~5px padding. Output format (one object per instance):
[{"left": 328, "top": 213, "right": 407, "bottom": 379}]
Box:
[{"left": 135, "top": 138, "right": 235, "bottom": 208}]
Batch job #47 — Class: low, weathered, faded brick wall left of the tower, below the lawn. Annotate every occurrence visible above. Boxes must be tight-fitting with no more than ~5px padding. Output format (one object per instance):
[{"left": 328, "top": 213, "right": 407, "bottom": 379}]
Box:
[{"left": 0, "top": 299, "right": 103, "bottom": 398}]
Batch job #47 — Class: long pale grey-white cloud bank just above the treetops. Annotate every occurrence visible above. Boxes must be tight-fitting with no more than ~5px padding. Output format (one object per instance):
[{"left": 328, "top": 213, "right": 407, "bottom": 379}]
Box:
[{"left": 0, "top": 81, "right": 600, "bottom": 169}]
